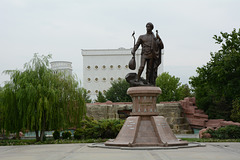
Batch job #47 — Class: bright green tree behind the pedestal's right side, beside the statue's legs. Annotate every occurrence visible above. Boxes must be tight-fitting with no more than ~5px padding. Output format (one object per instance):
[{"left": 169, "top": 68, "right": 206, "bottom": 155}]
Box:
[{"left": 156, "top": 72, "right": 192, "bottom": 102}]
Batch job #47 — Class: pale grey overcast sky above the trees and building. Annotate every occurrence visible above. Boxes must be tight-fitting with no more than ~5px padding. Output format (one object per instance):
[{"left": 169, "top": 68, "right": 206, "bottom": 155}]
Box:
[{"left": 0, "top": 0, "right": 240, "bottom": 86}]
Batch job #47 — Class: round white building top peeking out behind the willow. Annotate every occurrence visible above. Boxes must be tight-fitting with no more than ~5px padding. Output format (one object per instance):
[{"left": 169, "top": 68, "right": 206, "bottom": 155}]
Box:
[{"left": 50, "top": 61, "right": 72, "bottom": 76}]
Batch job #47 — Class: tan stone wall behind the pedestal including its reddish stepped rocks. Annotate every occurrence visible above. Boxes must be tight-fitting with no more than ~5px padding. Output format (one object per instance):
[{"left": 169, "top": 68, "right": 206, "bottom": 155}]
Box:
[{"left": 87, "top": 97, "right": 240, "bottom": 134}]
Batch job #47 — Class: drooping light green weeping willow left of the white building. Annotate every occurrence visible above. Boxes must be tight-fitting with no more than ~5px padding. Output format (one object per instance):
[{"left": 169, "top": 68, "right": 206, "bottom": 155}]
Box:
[{"left": 3, "top": 54, "right": 86, "bottom": 141}]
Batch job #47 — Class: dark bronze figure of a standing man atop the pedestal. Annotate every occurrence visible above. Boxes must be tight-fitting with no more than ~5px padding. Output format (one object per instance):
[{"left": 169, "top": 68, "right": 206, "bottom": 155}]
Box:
[{"left": 132, "top": 22, "right": 164, "bottom": 85}]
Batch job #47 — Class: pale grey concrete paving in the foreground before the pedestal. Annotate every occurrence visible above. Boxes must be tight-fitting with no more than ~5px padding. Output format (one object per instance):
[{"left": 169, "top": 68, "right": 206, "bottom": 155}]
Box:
[{"left": 0, "top": 143, "right": 240, "bottom": 160}]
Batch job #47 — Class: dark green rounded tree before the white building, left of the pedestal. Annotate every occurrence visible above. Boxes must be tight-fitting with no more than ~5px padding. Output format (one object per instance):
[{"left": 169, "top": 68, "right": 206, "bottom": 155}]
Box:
[{"left": 105, "top": 79, "right": 132, "bottom": 102}]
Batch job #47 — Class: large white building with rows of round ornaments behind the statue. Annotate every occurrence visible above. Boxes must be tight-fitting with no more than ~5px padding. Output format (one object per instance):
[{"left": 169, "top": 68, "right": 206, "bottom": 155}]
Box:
[{"left": 82, "top": 48, "right": 163, "bottom": 100}]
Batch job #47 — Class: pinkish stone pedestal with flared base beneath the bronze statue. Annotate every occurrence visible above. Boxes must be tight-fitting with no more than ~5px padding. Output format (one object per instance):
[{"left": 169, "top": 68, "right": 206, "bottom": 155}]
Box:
[{"left": 105, "top": 86, "right": 188, "bottom": 147}]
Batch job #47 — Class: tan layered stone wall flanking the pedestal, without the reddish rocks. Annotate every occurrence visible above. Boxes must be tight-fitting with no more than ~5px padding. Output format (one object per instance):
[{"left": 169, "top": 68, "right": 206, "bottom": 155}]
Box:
[{"left": 87, "top": 101, "right": 192, "bottom": 134}]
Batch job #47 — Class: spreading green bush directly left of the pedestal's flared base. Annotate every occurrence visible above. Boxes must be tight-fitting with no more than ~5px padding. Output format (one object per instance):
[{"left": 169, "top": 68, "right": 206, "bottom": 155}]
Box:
[{"left": 74, "top": 118, "right": 124, "bottom": 139}]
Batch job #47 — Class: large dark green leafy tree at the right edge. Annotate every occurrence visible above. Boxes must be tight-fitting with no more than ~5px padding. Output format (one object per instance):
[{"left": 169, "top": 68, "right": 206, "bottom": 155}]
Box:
[{"left": 190, "top": 29, "right": 240, "bottom": 120}]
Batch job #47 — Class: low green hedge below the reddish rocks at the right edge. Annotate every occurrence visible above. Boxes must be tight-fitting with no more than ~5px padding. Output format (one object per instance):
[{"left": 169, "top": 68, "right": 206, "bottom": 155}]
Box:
[{"left": 207, "top": 125, "right": 240, "bottom": 139}]
